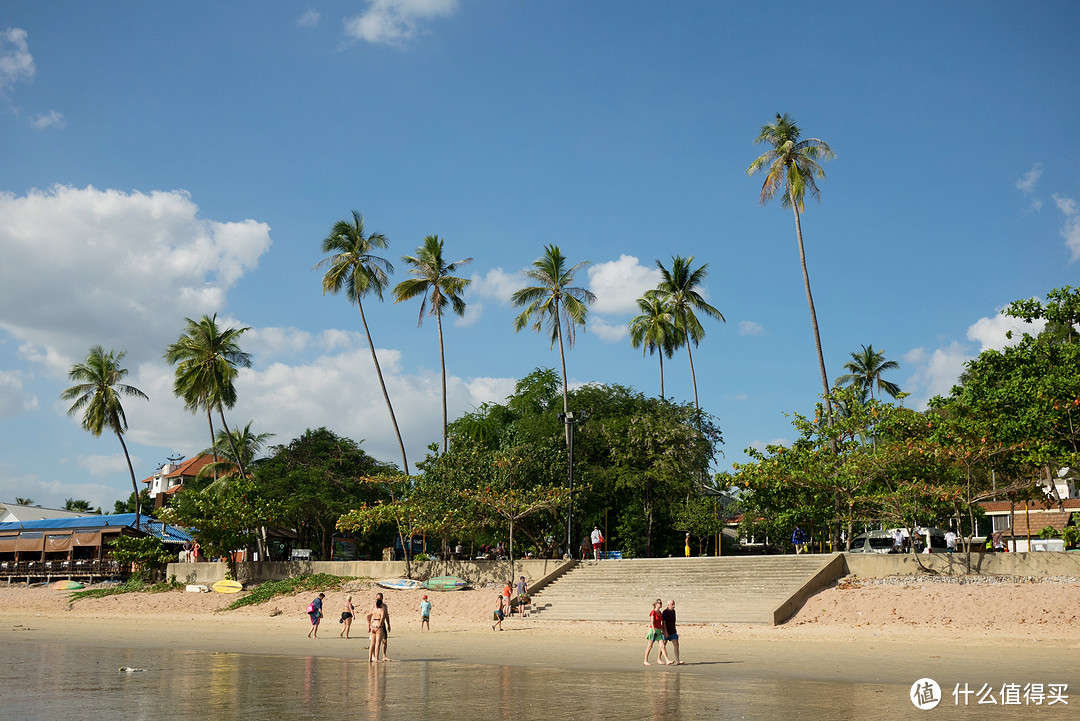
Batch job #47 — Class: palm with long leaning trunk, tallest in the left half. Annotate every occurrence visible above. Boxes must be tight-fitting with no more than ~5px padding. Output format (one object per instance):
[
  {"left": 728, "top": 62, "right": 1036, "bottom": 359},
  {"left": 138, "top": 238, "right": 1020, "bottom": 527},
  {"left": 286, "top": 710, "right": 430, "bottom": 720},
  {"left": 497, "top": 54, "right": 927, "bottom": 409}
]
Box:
[{"left": 315, "top": 210, "right": 408, "bottom": 475}]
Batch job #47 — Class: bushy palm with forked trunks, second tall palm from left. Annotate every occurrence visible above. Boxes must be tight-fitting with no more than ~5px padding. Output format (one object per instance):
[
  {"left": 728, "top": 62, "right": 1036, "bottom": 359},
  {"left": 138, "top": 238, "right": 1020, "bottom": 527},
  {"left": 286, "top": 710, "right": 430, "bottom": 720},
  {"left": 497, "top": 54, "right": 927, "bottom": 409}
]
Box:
[{"left": 164, "top": 313, "right": 252, "bottom": 475}]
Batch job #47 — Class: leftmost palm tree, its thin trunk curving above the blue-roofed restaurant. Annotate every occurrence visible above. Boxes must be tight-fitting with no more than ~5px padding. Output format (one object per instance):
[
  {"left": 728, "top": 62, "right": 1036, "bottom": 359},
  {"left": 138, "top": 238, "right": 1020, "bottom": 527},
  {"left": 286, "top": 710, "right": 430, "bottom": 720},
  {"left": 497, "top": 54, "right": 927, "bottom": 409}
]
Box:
[{"left": 60, "top": 345, "right": 149, "bottom": 528}]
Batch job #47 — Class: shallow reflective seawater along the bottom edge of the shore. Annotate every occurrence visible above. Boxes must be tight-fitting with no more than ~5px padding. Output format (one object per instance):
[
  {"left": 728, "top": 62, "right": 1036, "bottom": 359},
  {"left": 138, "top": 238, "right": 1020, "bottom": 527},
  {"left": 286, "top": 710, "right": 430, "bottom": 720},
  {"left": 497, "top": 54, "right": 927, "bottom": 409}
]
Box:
[{"left": 0, "top": 643, "right": 1072, "bottom": 721}]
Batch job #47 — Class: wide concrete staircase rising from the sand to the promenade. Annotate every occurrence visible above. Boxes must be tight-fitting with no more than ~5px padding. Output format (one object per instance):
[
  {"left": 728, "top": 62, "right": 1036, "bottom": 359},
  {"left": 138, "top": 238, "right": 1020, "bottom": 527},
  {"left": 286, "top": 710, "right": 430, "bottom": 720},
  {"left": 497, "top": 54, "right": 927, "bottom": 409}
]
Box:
[{"left": 531, "top": 554, "right": 845, "bottom": 625}]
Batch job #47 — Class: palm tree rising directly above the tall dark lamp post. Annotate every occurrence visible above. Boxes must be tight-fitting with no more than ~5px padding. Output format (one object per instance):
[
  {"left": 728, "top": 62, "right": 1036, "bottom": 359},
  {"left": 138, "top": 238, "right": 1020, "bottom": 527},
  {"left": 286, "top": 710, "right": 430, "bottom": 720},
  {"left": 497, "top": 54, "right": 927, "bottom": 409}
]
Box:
[{"left": 511, "top": 245, "right": 596, "bottom": 445}]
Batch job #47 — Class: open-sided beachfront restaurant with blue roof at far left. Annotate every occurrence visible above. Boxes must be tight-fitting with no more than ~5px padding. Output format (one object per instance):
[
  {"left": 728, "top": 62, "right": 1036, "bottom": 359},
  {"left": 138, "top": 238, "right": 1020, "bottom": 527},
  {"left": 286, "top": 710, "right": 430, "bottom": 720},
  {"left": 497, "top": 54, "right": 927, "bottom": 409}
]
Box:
[{"left": 0, "top": 513, "right": 191, "bottom": 583}]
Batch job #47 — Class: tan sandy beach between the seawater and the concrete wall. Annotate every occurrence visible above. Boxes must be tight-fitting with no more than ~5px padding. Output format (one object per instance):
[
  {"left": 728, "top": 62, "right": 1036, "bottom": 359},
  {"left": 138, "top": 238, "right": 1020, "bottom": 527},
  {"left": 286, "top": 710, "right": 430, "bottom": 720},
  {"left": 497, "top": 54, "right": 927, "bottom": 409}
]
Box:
[{"left": 0, "top": 579, "right": 1080, "bottom": 688}]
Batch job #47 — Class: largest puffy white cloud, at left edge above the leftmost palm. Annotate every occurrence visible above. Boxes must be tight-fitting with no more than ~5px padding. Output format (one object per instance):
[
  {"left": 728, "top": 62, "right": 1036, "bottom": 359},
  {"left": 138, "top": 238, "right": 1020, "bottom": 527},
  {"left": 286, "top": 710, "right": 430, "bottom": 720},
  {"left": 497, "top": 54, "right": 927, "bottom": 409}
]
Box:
[{"left": 0, "top": 186, "right": 270, "bottom": 375}]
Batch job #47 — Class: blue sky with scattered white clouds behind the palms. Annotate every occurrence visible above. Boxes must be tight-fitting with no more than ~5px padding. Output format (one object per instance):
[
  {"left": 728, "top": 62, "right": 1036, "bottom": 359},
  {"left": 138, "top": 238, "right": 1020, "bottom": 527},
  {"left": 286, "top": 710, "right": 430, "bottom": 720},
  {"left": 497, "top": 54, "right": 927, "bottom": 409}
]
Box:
[{"left": 0, "top": 0, "right": 1080, "bottom": 508}]
